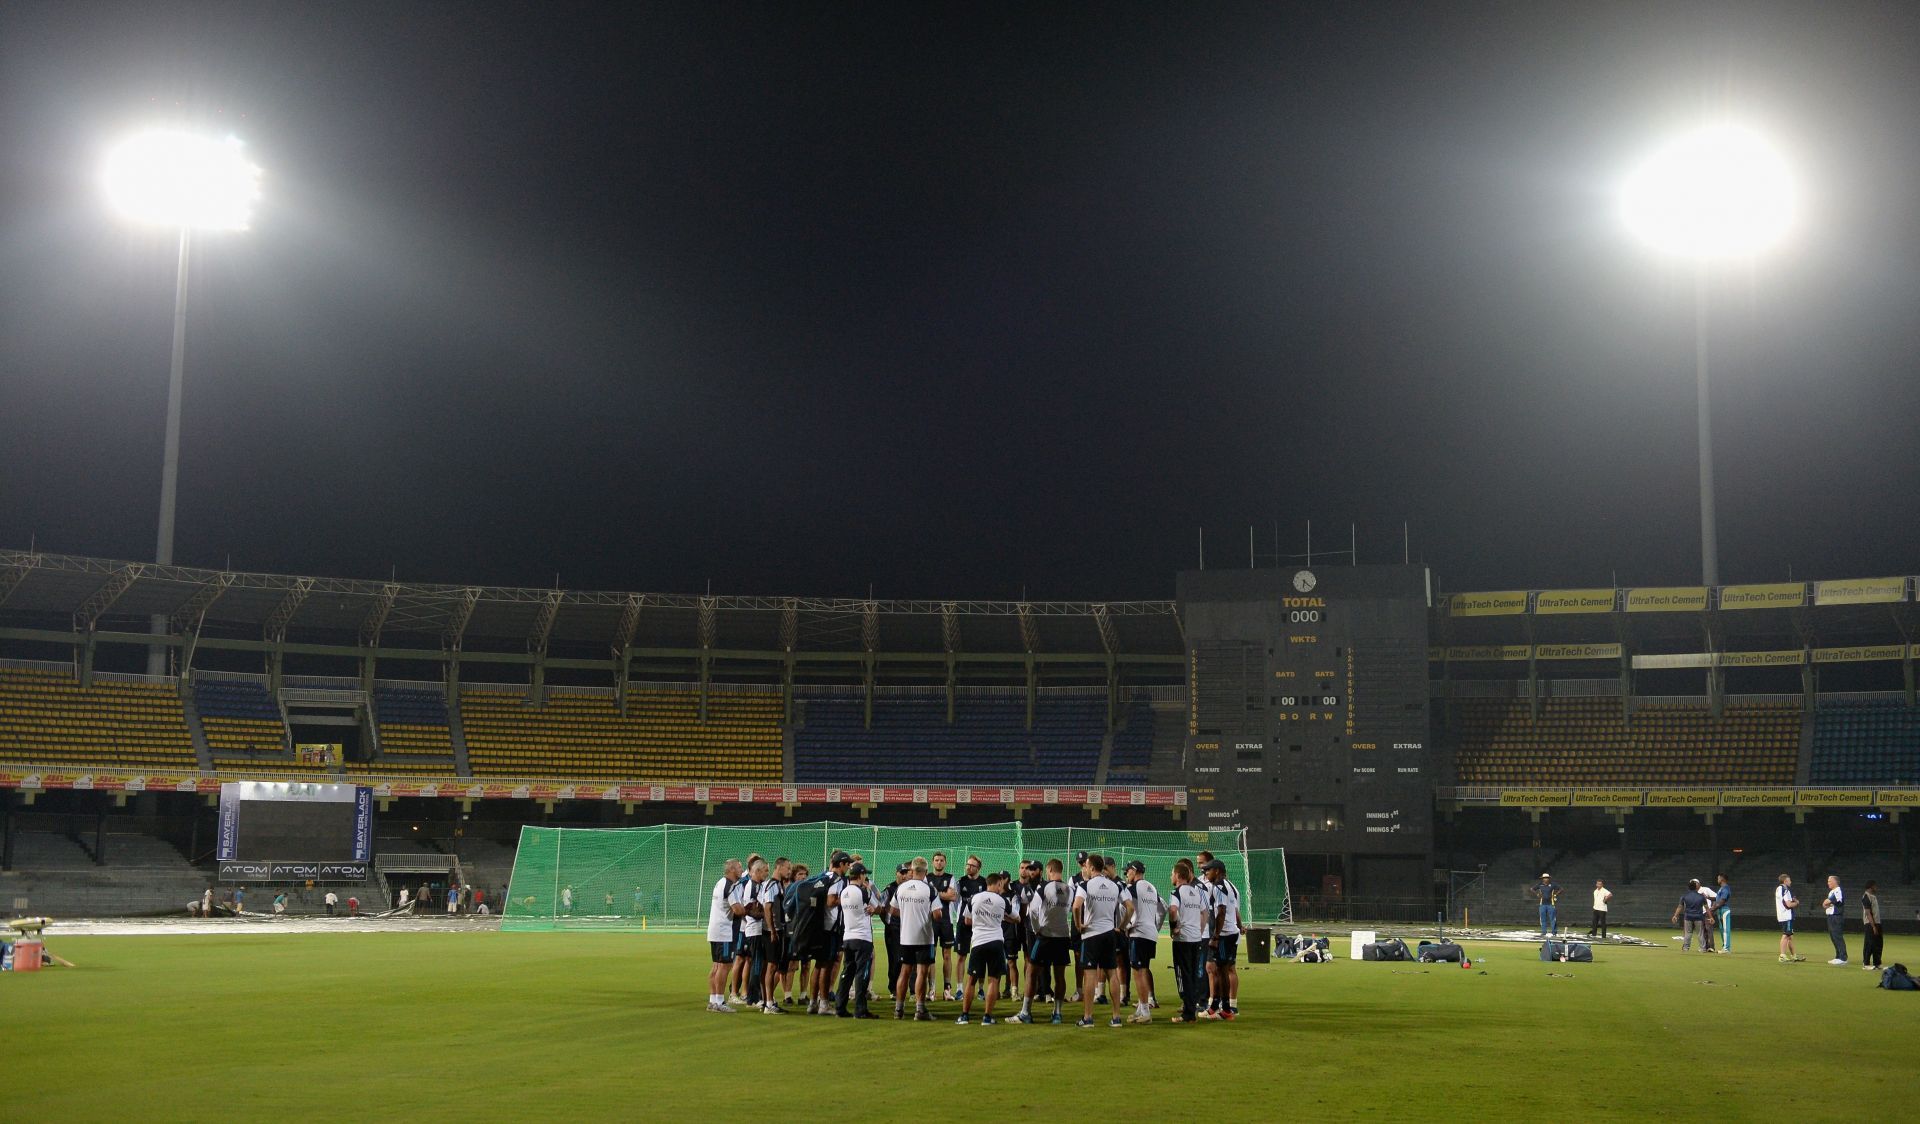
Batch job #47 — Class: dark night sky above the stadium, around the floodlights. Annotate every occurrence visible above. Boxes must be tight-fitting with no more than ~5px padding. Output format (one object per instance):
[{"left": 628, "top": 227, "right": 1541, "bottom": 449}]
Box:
[{"left": 0, "top": 0, "right": 1920, "bottom": 599}]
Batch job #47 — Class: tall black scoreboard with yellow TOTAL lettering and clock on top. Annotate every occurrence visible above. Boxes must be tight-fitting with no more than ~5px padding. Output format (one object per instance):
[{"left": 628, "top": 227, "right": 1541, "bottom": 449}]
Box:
[{"left": 1179, "top": 565, "right": 1436, "bottom": 893}]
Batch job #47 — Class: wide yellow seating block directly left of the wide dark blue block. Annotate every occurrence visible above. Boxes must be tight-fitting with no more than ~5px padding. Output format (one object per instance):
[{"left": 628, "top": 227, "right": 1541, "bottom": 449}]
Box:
[{"left": 461, "top": 688, "right": 785, "bottom": 784}]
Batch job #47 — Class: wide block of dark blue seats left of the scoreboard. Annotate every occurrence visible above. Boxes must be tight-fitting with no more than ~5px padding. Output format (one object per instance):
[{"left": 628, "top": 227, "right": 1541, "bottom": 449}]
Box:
[{"left": 793, "top": 696, "right": 1105, "bottom": 784}]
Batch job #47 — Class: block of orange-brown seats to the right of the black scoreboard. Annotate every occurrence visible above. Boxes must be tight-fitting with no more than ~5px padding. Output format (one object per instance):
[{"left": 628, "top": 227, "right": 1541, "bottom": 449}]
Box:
[{"left": 1453, "top": 697, "right": 1801, "bottom": 786}]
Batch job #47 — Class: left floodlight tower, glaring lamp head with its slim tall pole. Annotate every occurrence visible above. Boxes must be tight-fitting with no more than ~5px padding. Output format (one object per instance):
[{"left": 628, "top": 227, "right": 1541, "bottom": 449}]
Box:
[{"left": 104, "top": 129, "right": 259, "bottom": 674}]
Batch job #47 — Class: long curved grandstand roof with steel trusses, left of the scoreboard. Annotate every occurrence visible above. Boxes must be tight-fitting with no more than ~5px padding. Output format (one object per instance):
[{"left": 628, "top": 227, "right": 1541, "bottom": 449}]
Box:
[{"left": 0, "top": 550, "right": 1185, "bottom": 657}]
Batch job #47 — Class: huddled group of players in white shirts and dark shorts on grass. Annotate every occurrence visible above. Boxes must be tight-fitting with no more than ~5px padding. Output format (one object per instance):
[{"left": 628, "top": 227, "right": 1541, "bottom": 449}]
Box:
[{"left": 707, "top": 851, "right": 1240, "bottom": 1026}]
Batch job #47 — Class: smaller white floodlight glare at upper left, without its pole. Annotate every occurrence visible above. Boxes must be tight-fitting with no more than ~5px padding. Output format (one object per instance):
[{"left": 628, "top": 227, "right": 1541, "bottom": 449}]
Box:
[{"left": 106, "top": 129, "right": 259, "bottom": 231}]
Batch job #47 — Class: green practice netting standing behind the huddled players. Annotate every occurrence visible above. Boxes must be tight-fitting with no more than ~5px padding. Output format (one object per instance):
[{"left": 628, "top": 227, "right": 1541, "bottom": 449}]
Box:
[{"left": 503, "top": 822, "right": 1286, "bottom": 930}]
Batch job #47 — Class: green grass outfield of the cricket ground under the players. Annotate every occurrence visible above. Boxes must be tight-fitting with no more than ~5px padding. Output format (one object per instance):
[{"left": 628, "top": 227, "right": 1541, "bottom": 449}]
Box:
[{"left": 0, "top": 932, "right": 1920, "bottom": 1122}]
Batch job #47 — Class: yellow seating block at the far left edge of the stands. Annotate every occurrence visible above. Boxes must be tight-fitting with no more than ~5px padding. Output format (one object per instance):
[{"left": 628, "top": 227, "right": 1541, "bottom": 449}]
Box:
[{"left": 0, "top": 669, "right": 198, "bottom": 769}]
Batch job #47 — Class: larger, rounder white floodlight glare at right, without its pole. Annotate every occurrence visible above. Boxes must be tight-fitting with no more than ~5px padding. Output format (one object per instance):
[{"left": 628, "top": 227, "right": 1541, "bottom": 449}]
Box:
[{"left": 1620, "top": 123, "right": 1799, "bottom": 261}]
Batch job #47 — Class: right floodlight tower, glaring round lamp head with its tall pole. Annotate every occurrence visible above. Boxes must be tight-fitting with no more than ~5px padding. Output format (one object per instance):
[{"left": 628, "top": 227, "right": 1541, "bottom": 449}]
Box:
[{"left": 1620, "top": 121, "right": 1799, "bottom": 586}]
